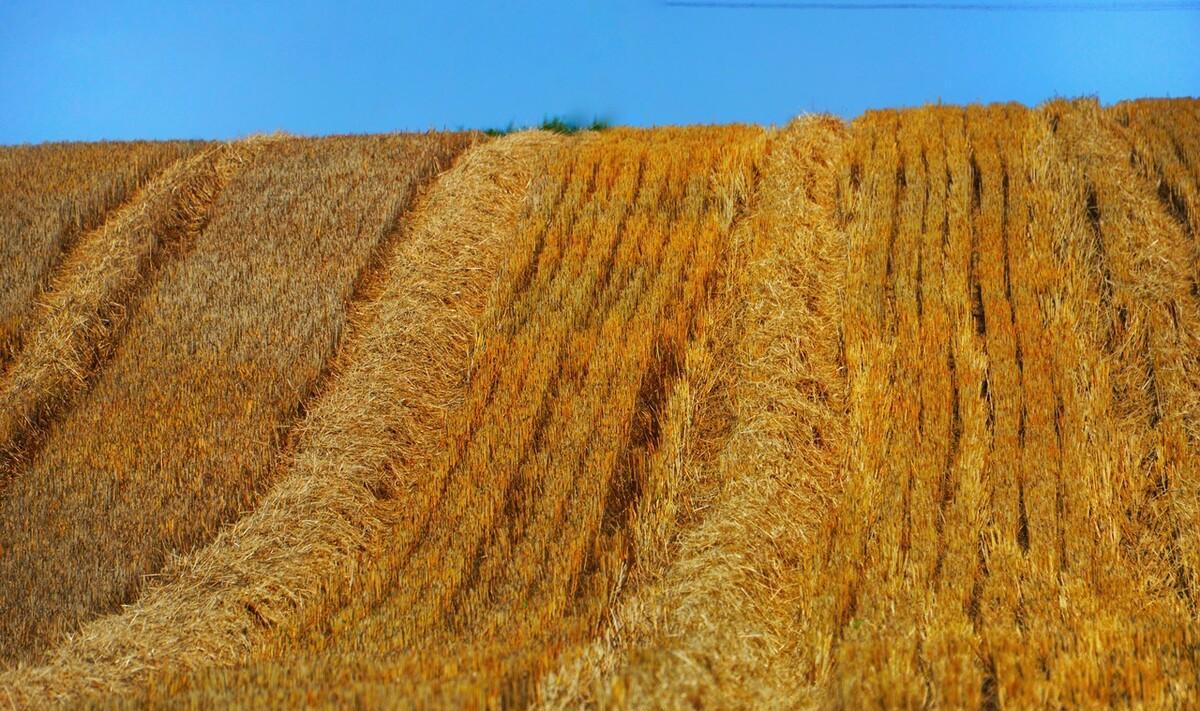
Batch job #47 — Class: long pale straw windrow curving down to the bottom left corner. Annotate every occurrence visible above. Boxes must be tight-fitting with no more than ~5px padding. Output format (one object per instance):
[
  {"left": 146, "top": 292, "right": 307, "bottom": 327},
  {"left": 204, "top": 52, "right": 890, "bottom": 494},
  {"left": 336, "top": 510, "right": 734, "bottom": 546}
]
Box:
[{"left": 0, "top": 133, "right": 549, "bottom": 705}]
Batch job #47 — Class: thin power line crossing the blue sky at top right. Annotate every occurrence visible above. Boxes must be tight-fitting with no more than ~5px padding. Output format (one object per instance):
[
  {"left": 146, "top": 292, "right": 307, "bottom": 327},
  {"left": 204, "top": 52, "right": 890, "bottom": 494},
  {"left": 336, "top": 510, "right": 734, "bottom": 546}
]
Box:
[{"left": 664, "top": 0, "right": 1200, "bottom": 12}]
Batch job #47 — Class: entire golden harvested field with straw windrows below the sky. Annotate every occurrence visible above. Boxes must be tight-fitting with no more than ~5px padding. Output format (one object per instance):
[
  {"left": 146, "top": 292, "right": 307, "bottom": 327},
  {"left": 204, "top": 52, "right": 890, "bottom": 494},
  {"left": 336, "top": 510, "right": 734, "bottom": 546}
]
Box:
[{"left": 0, "top": 100, "right": 1200, "bottom": 710}]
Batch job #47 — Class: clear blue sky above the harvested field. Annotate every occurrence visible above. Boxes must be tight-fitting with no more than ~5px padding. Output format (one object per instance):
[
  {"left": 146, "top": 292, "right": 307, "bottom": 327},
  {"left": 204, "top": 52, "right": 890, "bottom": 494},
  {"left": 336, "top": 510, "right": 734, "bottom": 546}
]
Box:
[{"left": 0, "top": 0, "right": 1200, "bottom": 144}]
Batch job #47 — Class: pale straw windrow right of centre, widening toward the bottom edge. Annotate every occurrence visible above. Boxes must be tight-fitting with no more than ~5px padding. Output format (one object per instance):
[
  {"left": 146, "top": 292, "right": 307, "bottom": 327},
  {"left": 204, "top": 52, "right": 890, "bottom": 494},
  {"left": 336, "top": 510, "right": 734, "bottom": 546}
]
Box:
[{"left": 541, "top": 118, "right": 846, "bottom": 709}]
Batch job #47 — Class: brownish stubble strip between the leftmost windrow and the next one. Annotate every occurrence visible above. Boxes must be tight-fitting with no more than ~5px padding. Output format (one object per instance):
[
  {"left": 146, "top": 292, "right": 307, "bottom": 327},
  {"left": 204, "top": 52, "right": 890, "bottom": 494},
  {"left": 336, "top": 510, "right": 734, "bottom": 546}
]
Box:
[{"left": 0, "top": 133, "right": 475, "bottom": 661}]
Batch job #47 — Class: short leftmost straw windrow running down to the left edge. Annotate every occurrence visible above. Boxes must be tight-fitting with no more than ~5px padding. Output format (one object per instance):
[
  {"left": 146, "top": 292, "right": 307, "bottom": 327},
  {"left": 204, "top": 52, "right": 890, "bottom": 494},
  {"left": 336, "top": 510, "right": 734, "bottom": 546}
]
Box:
[{"left": 0, "top": 142, "right": 257, "bottom": 482}]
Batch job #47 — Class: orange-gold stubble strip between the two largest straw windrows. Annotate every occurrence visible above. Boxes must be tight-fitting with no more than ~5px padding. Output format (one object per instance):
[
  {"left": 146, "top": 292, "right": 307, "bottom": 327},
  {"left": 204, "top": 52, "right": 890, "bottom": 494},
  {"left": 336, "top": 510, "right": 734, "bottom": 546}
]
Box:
[{"left": 105, "top": 127, "right": 766, "bottom": 707}]
